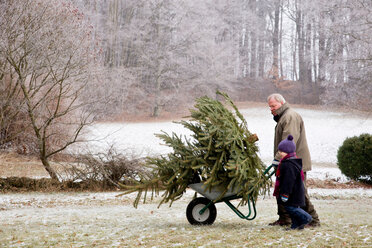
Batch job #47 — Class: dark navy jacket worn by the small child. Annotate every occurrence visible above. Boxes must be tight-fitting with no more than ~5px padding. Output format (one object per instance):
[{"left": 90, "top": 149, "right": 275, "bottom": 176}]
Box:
[{"left": 279, "top": 158, "right": 305, "bottom": 207}]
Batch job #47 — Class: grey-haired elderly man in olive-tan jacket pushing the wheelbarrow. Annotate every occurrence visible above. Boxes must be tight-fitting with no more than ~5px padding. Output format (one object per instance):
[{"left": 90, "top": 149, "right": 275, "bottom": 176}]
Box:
[{"left": 267, "top": 94, "right": 320, "bottom": 226}]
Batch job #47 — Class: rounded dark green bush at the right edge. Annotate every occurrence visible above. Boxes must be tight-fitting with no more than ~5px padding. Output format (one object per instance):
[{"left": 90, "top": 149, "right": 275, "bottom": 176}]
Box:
[{"left": 337, "top": 134, "right": 372, "bottom": 184}]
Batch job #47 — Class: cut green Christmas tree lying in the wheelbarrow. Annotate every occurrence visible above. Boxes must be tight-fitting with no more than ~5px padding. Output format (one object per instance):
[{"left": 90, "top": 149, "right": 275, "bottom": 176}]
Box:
[{"left": 121, "top": 92, "right": 271, "bottom": 207}]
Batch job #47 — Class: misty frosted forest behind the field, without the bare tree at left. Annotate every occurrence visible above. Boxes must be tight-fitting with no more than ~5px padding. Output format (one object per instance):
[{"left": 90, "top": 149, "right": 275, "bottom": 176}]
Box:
[{"left": 74, "top": 0, "right": 372, "bottom": 118}]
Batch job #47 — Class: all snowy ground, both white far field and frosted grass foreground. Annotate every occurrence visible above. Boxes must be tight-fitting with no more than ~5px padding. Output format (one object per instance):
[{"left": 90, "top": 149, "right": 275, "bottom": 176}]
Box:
[{"left": 0, "top": 107, "right": 372, "bottom": 248}]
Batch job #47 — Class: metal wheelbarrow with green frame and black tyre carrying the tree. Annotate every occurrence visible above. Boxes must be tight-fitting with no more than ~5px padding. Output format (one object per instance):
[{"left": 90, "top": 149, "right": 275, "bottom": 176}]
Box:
[{"left": 186, "top": 165, "right": 275, "bottom": 225}]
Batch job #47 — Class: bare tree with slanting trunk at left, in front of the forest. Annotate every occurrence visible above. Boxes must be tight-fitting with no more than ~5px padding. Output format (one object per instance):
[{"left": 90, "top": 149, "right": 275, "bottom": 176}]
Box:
[{"left": 0, "top": 0, "right": 94, "bottom": 180}]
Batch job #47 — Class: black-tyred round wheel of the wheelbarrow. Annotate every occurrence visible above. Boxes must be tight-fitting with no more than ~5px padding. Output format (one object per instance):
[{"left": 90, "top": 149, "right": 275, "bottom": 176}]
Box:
[{"left": 186, "top": 197, "right": 217, "bottom": 225}]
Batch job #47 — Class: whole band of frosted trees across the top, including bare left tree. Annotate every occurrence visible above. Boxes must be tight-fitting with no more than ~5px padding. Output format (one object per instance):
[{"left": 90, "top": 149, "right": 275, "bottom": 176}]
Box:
[{"left": 0, "top": 0, "right": 372, "bottom": 179}]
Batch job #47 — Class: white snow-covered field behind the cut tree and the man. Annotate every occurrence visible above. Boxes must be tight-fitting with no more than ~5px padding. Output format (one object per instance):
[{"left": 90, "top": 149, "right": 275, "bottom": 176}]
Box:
[{"left": 85, "top": 107, "right": 372, "bottom": 182}]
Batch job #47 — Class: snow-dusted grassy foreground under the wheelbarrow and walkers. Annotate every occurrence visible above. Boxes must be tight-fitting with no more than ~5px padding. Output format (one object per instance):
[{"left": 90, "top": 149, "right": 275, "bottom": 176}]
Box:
[{"left": 0, "top": 189, "right": 372, "bottom": 248}]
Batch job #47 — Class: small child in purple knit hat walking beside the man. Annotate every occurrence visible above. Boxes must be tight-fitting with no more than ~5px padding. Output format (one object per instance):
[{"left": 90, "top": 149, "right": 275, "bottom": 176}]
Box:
[{"left": 274, "top": 135, "right": 312, "bottom": 229}]
